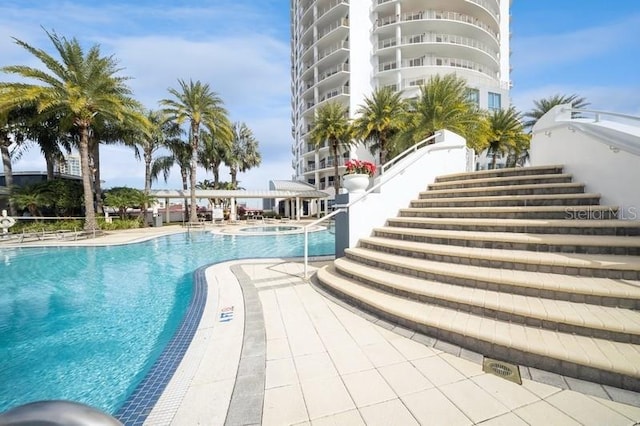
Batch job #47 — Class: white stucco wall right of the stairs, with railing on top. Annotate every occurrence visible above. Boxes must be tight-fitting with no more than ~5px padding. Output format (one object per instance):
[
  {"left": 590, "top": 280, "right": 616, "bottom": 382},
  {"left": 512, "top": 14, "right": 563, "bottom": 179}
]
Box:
[{"left": 530, "top": 106, "right": 640, "bottom": 220}]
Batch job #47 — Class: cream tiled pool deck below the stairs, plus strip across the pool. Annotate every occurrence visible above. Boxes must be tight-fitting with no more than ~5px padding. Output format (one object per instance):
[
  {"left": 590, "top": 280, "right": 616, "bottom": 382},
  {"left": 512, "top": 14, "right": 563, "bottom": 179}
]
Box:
[{"left": 2, "top": 227, "right": 640, "bottom": 425}]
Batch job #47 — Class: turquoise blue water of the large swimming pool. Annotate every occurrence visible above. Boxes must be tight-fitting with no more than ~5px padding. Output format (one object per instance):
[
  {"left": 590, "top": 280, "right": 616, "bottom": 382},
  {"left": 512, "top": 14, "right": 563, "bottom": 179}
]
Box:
[{"left": 0, "top": 231, "right": 334, "bottom": 413}]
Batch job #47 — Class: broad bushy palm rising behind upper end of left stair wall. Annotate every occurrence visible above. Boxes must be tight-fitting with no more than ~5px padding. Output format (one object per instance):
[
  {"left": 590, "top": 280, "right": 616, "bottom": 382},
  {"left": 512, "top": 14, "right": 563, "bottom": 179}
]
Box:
[{"left": 400, "top": 74, "right": 482, "bottom": 149}]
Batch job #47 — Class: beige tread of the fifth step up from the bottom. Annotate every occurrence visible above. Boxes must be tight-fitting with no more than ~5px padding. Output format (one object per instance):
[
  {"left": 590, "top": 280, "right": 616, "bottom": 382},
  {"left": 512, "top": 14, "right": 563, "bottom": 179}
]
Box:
[{"left": 374, "top": 226, "right": 640, "bottom": 247}]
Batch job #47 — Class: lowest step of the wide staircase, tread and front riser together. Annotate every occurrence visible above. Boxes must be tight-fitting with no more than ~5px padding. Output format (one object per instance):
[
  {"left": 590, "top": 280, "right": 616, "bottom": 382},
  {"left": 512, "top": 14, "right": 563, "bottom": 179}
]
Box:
[{"left": 317, "top": 265, "right": 640, "bottom": 391}]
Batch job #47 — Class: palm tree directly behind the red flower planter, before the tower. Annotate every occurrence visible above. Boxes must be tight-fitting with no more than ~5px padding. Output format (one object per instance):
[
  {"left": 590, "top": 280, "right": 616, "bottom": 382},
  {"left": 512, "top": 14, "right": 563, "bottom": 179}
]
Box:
[{"left": 353, "top": 87, "right": 407, "bottom": 165}]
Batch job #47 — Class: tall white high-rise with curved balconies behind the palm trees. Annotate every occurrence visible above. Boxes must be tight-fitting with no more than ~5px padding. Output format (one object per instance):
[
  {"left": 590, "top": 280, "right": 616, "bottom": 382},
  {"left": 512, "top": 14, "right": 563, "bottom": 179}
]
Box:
[{"left": 291, "top": 0, "right": 510, "bottom": 201}]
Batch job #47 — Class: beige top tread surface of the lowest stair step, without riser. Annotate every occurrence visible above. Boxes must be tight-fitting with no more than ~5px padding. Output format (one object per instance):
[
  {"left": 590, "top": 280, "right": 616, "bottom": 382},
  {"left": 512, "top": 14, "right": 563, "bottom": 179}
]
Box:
[{"left": 317, "top": 265, "right": 640, "bottom": 378}]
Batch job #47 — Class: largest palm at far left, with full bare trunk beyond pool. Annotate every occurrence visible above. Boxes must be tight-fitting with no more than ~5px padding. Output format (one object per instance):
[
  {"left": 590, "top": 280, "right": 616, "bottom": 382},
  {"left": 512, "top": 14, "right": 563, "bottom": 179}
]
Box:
[{"left": 0, "top": 32, "right": 139, "bottom": 231}]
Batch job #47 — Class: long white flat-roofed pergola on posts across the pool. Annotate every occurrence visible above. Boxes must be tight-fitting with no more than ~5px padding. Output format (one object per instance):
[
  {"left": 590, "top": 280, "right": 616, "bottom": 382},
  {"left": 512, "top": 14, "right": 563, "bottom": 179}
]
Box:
[{"left": 150, "top": 188, "right": 329, "bottom": 221}]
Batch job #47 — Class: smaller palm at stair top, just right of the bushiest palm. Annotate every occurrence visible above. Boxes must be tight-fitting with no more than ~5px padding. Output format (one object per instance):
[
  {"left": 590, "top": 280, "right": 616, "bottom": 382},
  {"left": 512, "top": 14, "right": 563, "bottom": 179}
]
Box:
[{"left": 487, "top": 106, "right": 530, "bottom": 169}]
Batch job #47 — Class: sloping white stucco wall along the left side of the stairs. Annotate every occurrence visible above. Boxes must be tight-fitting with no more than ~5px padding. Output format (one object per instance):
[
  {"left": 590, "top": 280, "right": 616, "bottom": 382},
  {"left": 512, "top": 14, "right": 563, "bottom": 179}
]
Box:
[{"left": 349, "top": 130, "right": 467, "bottom": 247}]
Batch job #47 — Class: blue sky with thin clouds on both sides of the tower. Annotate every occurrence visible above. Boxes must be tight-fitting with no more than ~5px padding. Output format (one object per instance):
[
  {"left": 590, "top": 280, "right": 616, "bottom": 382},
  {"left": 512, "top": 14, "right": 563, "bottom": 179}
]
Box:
[{"left": 0, "top": 0, "right": 640, "bottom": 196}]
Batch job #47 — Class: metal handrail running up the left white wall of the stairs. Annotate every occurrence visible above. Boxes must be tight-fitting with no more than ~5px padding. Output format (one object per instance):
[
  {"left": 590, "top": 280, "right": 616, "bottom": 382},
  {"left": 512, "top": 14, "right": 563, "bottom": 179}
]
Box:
[{"left": 304, "top": 132, "right": 448, "bottom": 280}]
